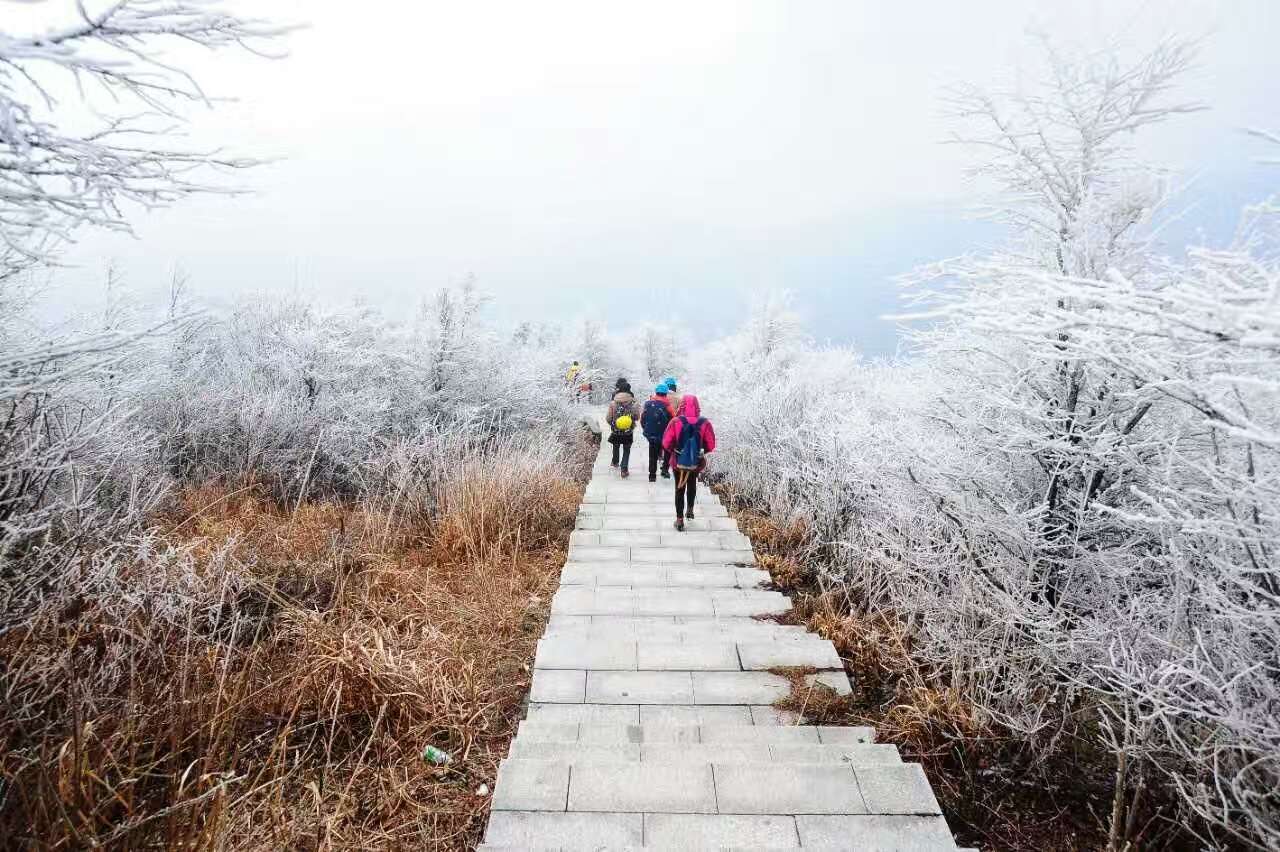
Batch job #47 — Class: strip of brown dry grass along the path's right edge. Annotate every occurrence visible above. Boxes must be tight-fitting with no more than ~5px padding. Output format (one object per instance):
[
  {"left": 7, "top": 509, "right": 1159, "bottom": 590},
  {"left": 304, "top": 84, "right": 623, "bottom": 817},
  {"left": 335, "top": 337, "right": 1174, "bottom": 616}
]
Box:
[{"left": 713, "top": 476, "right": 1202, "bottom": 852}]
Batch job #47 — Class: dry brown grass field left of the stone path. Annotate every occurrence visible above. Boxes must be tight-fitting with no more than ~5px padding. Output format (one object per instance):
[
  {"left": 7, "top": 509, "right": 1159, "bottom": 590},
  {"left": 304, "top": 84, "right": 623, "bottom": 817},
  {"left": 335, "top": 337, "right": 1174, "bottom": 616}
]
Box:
[{"left": 0, "top": 445, "right": 581, "bottom": 849}]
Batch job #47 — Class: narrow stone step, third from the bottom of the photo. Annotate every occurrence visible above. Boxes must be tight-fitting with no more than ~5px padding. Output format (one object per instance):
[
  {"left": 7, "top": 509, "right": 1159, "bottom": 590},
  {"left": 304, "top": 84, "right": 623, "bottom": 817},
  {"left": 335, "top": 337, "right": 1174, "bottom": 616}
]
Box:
[{"left": 509, "top": 737, "right": 902, "bottom": 766}]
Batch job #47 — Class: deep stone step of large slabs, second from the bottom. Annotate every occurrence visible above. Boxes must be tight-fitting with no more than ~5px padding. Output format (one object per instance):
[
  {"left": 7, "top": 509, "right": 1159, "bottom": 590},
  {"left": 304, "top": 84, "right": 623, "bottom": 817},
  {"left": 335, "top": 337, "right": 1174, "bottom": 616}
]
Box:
[{"left": 492, "top": 757, "right": 941, "bottom": 816}]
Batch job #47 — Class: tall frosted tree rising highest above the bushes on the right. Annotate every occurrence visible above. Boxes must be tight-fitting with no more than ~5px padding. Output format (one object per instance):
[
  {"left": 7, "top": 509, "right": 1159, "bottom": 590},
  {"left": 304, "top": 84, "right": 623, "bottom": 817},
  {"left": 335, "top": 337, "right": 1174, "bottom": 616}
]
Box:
[{"left": 922, "top": 34, "right": 1197, "bottom": 601}]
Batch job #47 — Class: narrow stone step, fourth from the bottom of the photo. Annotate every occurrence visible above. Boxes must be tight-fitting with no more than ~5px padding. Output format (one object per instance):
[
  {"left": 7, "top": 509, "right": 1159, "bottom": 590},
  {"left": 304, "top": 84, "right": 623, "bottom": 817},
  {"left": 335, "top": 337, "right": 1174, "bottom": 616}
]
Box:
[{"left": 516, "top": 719, "right": 876, "bottom": 746}]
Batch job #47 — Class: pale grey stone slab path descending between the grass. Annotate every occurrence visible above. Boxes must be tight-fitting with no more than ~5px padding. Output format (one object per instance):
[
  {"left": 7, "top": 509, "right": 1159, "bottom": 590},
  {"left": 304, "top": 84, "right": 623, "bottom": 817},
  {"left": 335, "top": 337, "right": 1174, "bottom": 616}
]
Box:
[{"left": 480, "top": 427, "right": 956, "bottom": 852}]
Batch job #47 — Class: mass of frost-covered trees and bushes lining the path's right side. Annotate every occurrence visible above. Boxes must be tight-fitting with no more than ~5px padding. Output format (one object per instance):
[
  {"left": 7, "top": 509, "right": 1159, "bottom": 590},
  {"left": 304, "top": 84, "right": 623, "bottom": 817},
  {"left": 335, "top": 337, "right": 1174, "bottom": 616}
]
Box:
[{"left": 700, "top": 43, "right": 1280, "bottom": 849}]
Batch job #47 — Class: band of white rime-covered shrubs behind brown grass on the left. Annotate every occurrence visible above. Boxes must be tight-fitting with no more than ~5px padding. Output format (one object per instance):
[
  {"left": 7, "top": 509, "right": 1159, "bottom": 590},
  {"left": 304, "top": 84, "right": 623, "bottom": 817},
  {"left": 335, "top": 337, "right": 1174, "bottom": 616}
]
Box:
[{"left": 0, "top": 280, "right": 588, "bottom": 624}]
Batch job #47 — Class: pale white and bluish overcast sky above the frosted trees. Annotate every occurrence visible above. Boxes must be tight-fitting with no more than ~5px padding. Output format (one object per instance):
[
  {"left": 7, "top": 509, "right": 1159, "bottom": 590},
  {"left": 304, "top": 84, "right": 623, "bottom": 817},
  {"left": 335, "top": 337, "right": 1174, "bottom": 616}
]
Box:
[{"left": 20, "top": 0, "right": 1280, "bottom": 352}]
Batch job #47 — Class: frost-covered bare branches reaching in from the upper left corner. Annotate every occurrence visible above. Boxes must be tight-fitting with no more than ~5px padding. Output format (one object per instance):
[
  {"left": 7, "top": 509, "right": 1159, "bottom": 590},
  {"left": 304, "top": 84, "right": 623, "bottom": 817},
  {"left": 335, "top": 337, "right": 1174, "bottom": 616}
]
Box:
[{"left": 0, "top": 0, "right": 283, "bottom": 278}]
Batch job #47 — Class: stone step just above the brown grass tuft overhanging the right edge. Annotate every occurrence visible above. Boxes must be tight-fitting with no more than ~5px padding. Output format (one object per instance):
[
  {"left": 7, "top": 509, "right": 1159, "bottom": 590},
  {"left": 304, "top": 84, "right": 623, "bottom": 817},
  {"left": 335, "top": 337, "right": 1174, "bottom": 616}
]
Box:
[{"left": 534, "top": 637, "right": 844, "bottom": 672}]
